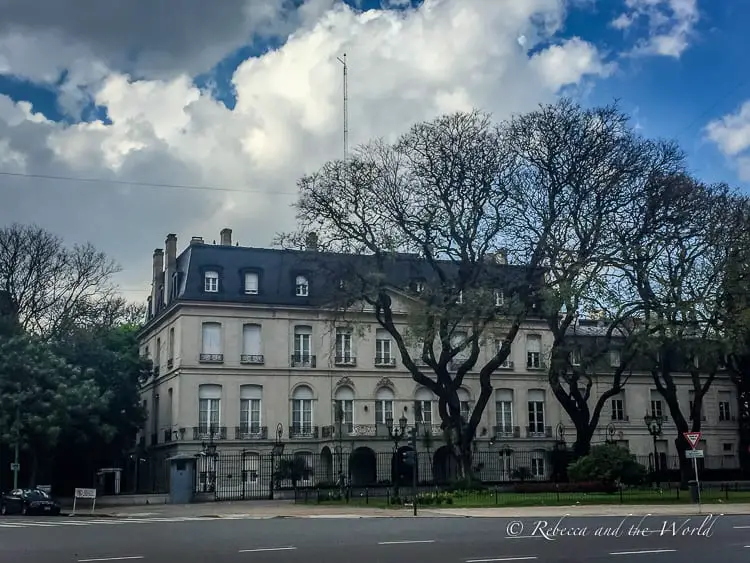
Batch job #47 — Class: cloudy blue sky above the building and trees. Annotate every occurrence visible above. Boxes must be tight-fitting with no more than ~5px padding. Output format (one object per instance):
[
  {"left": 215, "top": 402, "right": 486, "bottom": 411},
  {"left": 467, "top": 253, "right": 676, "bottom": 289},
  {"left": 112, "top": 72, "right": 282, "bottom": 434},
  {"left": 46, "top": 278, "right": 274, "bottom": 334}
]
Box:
[{"left": 0, "top": 0, "right": 750, "bottom": 296}]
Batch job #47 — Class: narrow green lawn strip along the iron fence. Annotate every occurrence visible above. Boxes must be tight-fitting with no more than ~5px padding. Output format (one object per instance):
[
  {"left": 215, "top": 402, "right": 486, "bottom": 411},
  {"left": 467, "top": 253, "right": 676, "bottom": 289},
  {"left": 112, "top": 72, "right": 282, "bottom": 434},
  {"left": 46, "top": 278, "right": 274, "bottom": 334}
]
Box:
[{"left": 297, "top": 488, "right": 750, "bottom": 508}]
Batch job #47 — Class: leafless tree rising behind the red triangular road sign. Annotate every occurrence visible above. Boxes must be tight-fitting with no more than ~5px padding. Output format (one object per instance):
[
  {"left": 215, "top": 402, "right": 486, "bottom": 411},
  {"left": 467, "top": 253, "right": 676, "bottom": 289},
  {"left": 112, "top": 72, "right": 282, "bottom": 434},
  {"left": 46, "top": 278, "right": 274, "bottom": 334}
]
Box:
[{"left": 618, "top": 174, "right": 733, "bottom": 479}]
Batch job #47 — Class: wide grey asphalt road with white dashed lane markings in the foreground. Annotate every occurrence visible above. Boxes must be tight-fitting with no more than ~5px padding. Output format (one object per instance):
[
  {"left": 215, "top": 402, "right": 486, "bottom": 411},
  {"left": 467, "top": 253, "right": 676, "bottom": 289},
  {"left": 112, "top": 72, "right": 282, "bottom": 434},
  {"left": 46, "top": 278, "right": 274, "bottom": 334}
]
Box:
[{"left": 0, "top": 515, "right": 750, "bottom": 563}]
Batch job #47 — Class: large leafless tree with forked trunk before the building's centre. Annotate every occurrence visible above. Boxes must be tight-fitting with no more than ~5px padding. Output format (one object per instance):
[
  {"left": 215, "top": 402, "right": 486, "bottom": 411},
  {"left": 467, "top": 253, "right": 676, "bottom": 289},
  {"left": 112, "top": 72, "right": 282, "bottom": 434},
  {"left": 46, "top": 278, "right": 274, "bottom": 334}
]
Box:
[{"left": 282, "top": 111, "right": 546, "bottom": 478}]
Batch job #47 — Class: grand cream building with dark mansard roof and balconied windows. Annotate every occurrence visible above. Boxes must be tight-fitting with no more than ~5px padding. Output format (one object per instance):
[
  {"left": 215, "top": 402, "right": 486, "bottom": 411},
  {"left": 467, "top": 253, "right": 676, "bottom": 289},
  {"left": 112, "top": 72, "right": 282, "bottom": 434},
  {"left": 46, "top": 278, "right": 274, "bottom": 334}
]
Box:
[{"left": 141, "top": 229, "right": 738, "bottom": 494}]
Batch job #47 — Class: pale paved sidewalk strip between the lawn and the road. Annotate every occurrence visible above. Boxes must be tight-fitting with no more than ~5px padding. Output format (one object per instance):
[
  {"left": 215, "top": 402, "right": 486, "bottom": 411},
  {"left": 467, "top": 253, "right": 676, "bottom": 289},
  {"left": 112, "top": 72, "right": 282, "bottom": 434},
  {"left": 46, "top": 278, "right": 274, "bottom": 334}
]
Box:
[{"left": 76, "top": 501, "right": 750, "bottom": 519}]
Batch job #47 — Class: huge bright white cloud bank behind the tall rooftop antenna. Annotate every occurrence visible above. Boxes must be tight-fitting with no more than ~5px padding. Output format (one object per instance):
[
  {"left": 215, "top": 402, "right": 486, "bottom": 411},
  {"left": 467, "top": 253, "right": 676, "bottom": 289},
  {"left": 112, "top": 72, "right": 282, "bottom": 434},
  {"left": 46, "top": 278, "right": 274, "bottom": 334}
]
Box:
[{"left": 0, "top": 0, "right": 611, "bottom": 298}]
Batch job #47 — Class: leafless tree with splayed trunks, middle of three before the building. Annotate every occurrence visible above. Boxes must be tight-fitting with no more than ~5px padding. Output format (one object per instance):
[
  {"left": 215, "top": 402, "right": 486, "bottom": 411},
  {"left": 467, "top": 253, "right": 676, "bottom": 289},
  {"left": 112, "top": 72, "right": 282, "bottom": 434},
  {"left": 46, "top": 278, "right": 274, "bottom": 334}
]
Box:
[{"left": 504, "top": 100, "right": 682, "bottom": 455}]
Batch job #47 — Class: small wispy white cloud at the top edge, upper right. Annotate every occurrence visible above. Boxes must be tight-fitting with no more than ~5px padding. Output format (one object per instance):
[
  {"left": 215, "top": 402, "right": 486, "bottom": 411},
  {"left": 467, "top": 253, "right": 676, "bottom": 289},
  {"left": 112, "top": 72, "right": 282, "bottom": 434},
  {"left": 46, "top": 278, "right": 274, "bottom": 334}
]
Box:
[{"left": 611, "top": 0, "right": 700, "bottom": 58}]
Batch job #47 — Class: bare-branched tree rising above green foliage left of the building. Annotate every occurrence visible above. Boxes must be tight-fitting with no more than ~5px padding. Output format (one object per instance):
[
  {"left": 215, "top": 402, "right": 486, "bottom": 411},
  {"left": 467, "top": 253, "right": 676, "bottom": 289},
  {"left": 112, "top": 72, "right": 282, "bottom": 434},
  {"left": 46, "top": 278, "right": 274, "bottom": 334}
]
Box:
[{"left": 0, "top": 224, "right": 119, "bottom": 338}]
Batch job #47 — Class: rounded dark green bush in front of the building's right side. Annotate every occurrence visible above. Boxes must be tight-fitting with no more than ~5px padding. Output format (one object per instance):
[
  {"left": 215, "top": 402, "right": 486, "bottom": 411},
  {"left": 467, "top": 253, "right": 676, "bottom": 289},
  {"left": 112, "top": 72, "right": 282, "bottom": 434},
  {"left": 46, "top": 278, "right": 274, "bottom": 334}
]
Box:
[{"left": 568, "top": 444, "right": 646, "bottom": 485}]
